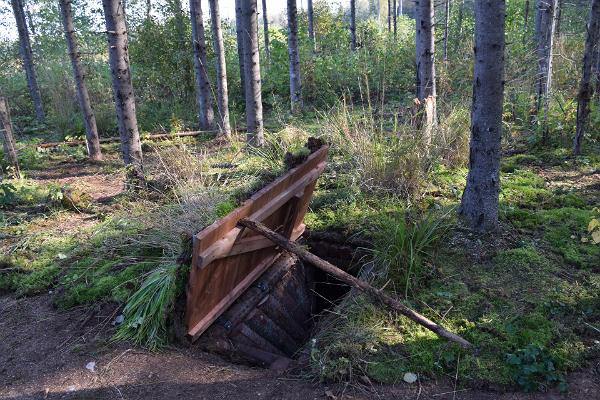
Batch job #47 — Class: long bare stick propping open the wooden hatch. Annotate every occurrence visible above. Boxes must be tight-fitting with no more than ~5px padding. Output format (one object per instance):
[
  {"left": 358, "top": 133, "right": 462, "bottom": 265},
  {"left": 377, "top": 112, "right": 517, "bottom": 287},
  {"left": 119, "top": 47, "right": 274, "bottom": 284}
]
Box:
[{"left": 238, "top": 218, "right": 473, "bottom": 348}]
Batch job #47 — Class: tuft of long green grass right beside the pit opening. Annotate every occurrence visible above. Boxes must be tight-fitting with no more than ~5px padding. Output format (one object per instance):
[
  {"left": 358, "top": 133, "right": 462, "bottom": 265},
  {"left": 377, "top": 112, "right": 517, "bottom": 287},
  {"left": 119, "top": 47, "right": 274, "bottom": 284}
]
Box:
[{"left": 373, "top": 209, "right": 448, "bottom": 298}]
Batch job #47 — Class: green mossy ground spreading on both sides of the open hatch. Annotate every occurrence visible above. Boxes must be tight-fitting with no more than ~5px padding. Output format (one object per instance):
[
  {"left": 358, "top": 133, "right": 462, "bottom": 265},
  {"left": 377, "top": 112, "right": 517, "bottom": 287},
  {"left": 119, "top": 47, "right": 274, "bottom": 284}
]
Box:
[{"left": 0, "top": 129, "right": 600, "bottom": 390}]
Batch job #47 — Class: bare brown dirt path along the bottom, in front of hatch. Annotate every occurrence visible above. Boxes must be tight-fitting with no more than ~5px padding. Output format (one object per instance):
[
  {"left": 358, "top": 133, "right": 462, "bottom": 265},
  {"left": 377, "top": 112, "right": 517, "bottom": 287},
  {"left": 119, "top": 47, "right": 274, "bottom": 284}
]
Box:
[{"left": 0, "top": 294, "right": 600, "bottom": 400}]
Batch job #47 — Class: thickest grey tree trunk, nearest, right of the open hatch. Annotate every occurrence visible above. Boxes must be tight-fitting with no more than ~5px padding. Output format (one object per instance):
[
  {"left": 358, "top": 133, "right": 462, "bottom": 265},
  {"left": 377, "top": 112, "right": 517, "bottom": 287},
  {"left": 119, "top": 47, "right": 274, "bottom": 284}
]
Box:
[{"left": 460, "top": 0, "right": 506, "bottom": 231}]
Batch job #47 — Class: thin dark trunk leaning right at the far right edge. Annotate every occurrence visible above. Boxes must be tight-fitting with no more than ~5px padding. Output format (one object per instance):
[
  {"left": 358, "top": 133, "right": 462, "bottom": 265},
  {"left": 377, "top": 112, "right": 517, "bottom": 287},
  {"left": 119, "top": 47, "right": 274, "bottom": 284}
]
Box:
[{"left": 573, "top": 0, "right": 600, "bottom": 156}]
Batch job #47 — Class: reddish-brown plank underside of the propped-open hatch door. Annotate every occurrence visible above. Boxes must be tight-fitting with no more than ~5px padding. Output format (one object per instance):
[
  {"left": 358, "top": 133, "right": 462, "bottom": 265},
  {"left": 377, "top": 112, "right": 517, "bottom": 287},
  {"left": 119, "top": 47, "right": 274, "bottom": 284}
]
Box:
[{"left": 186, "top": 146, "right": 329, "bottom": 340}]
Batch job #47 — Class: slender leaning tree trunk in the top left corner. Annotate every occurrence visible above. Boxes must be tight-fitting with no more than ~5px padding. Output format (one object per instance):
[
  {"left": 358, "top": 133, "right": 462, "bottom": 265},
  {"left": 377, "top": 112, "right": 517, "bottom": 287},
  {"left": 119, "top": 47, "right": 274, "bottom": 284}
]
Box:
[{"left": 11, "top": 0, "right": 45, "bottom": 123}]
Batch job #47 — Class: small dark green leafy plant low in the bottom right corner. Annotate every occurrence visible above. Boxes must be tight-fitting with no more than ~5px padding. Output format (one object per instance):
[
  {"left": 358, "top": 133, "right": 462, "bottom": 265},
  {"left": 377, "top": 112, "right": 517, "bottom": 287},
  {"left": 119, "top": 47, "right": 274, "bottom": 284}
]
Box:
[{"left": 506, "top": 344, "right": 567, "bottom": 392}]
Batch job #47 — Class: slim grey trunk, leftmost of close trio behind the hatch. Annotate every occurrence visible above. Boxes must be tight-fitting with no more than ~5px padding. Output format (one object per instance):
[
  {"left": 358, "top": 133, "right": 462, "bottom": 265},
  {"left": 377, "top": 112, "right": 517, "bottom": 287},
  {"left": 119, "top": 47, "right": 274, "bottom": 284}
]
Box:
[{"left": 190, "top": 0, "right": 214, "bottom": 131}]
